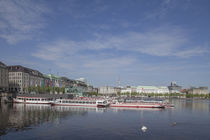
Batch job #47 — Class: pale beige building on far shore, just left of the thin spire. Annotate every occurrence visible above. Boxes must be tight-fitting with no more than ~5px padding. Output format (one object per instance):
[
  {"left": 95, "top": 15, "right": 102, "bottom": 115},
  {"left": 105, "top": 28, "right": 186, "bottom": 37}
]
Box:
[{"left": 98, "top": 86, "right": 120, "bottom": 95}]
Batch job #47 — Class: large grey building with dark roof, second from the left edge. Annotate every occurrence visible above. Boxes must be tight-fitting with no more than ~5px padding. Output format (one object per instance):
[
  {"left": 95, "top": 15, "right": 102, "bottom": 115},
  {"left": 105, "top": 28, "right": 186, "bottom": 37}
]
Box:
[{"left": 7, "top": 65, "right": 43, "bottom": 93}]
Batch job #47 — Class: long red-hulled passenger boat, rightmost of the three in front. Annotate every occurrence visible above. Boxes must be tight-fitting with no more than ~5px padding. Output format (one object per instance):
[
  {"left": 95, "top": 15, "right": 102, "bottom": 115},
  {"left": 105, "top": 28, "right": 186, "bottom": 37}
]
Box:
[{"left": 110, "top": 100, "right": 165, "bottom": 108}]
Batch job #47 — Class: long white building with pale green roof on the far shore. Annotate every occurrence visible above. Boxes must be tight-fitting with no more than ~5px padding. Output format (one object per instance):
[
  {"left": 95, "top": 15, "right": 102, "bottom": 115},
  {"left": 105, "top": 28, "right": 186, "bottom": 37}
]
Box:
[{"left": 136, "top": 86, "right": 169, "bottom": 94}]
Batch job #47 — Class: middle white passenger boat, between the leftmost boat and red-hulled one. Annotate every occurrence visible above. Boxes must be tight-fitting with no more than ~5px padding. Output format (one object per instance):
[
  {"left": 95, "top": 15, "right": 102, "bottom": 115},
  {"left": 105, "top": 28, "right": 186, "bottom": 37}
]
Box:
[{"left": 52, "top": 99, "right": 109, "bottom": 107}]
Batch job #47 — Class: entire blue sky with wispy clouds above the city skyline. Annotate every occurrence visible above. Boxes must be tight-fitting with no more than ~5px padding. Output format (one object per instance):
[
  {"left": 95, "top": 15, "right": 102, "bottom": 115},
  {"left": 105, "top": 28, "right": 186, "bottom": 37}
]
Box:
[{"left": 0, "top": 0, "right": 210, "bottom": 88}]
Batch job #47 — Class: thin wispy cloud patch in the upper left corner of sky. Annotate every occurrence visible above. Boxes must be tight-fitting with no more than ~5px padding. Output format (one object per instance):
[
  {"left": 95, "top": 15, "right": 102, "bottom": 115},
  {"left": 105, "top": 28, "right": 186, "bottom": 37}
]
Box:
[{"left": 0, "top": 0, "right": 49, "bottom": 44}]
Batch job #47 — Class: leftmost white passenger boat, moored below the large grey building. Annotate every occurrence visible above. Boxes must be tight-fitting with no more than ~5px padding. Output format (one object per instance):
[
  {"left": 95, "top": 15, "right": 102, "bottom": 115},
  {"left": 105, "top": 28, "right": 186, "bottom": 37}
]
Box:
[{"left": 13, "top": 96, "right": 53, "bottom": 104}]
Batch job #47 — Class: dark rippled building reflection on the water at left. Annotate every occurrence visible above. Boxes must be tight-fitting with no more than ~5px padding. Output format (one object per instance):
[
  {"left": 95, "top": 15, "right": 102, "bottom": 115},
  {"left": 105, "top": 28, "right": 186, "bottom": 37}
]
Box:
[{"left": 0, "top": 104, "right": 106, "bottom": 136}]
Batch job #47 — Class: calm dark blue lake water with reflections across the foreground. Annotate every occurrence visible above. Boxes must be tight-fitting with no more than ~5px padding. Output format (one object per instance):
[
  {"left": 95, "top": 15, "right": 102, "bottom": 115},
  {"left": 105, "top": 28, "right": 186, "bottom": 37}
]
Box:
[{"left": 0, "top": 100, "right": 210, "bottom": 140}]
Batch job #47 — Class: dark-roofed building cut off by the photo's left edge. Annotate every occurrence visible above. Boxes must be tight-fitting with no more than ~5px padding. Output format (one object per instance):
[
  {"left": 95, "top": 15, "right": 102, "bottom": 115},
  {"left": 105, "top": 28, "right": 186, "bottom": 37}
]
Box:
[{"left": 0, "top": 62, "right": 9, "bottom": 92}]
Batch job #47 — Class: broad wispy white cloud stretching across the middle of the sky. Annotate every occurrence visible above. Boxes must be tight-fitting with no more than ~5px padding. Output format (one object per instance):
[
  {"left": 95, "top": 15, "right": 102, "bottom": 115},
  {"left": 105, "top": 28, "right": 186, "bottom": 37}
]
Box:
[{"left": 32, "top": 28, "right": 209, "bottom": 86}]
